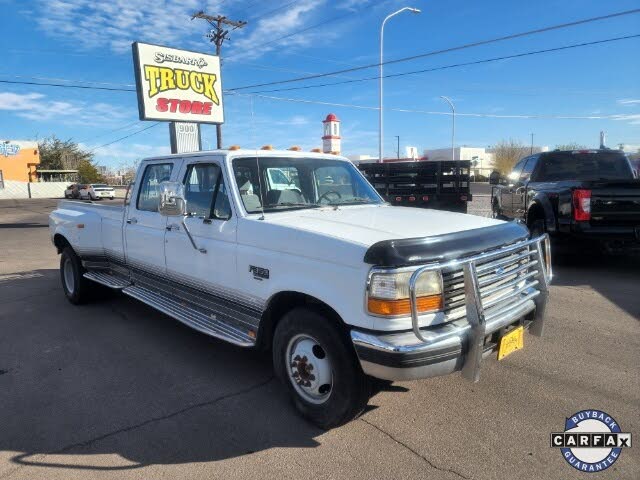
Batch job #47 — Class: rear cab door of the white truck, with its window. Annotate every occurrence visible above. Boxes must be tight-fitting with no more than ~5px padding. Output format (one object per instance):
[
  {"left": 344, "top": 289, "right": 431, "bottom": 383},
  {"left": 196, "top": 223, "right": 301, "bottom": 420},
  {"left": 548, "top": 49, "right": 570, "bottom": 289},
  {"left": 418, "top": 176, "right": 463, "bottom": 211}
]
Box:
[{"left": 124, "top": 159, "right": 182, "bottom": 283}]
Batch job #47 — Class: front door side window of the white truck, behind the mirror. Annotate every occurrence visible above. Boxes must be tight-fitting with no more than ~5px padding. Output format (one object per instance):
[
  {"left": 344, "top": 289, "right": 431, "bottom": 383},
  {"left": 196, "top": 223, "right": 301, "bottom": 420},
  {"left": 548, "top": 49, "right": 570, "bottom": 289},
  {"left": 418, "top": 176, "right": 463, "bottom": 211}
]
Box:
[{"left": 184, "top": 163, "right": 231, "bottom": 219}]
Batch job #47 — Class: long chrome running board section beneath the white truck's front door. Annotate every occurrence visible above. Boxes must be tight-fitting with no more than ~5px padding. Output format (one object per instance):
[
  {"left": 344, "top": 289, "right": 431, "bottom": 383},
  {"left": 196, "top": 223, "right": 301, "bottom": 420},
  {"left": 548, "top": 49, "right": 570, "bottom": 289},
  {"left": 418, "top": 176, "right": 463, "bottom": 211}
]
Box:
[{"left": 122, "top": 285, "right": 256, "bottom": 347}]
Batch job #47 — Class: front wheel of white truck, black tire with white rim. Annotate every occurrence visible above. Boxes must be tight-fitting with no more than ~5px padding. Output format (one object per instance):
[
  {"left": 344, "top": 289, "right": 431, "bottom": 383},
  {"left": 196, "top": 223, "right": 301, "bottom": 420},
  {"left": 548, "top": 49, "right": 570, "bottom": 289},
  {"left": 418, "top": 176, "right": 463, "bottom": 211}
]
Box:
[{"left": 273, "top": 307, "right": 369, "bottom": 429}]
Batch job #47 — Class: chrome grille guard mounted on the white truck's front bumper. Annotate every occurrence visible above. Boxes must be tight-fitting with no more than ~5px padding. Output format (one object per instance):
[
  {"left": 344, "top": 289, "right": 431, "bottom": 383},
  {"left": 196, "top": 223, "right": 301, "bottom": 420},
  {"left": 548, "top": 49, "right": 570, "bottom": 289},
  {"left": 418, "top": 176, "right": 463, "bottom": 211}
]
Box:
[{"left": 409, "top": 234, "right": 552, "bottom": 382}]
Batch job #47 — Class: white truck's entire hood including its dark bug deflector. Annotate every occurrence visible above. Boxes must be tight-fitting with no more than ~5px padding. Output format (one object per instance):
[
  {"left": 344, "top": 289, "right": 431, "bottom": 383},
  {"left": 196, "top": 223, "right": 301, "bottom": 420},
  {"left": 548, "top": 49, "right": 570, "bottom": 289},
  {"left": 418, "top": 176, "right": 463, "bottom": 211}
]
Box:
[{"left": 252, "top": 206, "right": 529, "bottom": 267}]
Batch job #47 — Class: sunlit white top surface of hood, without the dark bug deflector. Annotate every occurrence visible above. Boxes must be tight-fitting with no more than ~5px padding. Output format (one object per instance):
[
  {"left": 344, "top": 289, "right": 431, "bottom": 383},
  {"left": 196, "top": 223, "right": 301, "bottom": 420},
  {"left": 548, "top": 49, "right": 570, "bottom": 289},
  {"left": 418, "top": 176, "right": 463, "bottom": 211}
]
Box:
[{"left": 267, "top": 205, "right": 504, "bottom": 247}]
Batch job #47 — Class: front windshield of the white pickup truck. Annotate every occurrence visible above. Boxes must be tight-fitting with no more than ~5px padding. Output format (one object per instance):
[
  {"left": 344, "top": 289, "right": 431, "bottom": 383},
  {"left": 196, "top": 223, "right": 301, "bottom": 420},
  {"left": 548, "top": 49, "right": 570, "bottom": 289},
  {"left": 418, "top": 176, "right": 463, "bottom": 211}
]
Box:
[{"left": 233, "top": 157, "right": 383, "bottom": 213}]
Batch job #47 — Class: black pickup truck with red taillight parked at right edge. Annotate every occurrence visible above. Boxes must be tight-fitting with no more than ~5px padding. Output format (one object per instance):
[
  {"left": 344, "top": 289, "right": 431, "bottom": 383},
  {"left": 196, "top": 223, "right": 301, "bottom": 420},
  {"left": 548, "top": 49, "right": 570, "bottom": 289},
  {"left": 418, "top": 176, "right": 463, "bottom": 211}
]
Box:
[{"left": 491, "top": 149, "right": 640, "bottom": 252}]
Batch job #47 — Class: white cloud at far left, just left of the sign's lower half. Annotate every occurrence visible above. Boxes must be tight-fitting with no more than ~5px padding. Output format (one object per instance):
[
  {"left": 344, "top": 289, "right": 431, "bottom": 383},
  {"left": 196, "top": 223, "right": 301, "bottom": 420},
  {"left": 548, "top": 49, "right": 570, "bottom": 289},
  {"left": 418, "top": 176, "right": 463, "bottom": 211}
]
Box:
[{"left": 0, "top": 92, "right": 131, "bottom": 126}]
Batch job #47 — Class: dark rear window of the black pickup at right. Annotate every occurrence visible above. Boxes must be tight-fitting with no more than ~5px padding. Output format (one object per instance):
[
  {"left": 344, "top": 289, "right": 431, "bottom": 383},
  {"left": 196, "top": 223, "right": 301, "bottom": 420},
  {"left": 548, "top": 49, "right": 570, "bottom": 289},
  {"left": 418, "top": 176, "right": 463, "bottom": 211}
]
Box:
[{"left": 536, "top": 152, "right": 633, "bottom": 182}]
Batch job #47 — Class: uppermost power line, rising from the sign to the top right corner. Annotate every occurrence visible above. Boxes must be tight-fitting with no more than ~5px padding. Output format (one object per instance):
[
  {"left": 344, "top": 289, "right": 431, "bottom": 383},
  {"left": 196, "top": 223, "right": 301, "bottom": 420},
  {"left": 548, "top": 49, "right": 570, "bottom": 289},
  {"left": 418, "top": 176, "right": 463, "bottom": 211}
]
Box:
[{"left": 230, "top": 8, "right": 640, "bottom": 91}]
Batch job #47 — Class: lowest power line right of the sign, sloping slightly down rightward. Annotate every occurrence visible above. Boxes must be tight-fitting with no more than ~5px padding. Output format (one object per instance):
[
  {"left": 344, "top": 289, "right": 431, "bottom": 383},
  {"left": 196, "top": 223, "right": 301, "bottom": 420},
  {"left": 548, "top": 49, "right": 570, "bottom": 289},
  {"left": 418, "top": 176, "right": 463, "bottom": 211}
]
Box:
[{"left": 233, "top": 93, "right": 636, "bottom": 120}]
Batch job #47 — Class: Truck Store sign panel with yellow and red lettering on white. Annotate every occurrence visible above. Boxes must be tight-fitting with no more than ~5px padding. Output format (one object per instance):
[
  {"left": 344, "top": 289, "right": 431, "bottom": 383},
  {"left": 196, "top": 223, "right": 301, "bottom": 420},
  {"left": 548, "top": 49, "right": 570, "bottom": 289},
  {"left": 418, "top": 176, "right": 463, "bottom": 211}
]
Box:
[{"left": 132, "top": 42, "right": 224, "bottom": 123}]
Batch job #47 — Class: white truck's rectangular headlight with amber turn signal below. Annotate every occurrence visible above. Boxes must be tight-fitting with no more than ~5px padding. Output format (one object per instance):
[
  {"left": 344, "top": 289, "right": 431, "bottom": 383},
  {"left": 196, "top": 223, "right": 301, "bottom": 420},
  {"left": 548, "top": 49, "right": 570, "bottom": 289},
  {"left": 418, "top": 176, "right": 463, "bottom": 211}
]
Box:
[{"left": 367, "top": 270, "right": 444, "bottom": 317}]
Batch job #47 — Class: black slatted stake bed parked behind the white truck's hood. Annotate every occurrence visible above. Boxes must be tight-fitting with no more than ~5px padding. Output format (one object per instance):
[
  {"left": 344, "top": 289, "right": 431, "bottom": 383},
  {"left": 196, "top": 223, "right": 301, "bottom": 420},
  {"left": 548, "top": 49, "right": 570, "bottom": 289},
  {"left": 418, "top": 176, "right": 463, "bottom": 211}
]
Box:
[{"left": 354, "top": 160, "right": 471, "bottom": 213}]
